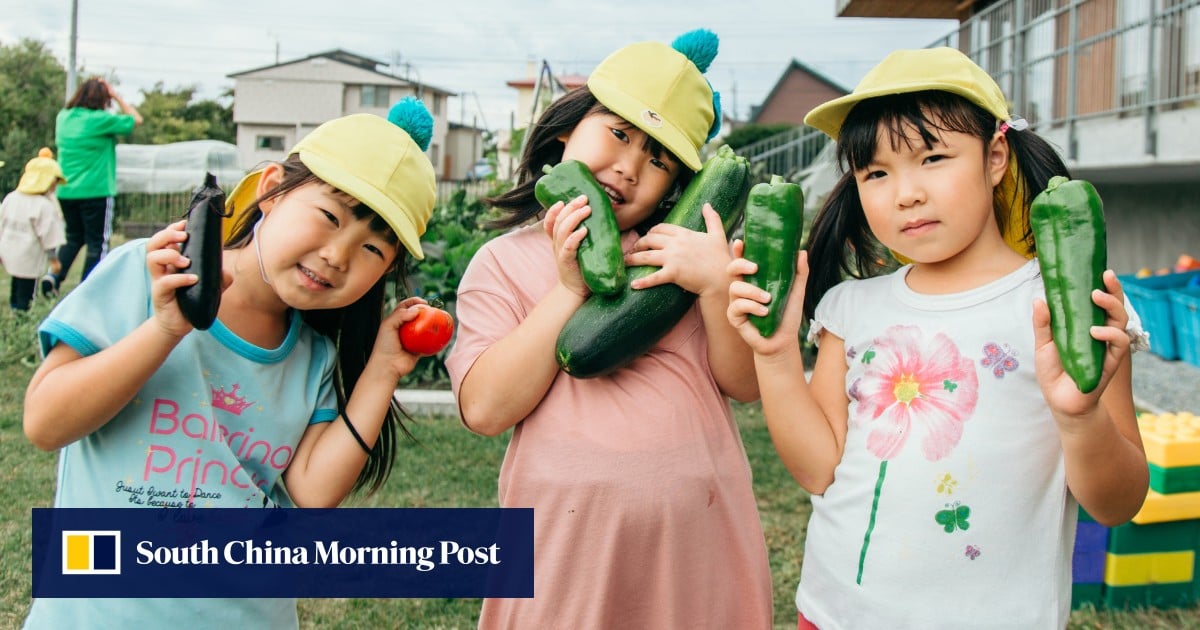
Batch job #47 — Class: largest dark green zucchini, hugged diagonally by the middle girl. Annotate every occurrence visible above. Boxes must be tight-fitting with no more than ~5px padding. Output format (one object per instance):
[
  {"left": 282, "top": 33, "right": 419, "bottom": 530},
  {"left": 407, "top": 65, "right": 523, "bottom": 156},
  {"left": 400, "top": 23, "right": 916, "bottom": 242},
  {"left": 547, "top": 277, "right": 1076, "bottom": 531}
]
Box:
[{"left": 554, "top": 145, "right": 750, "bottom": 378}]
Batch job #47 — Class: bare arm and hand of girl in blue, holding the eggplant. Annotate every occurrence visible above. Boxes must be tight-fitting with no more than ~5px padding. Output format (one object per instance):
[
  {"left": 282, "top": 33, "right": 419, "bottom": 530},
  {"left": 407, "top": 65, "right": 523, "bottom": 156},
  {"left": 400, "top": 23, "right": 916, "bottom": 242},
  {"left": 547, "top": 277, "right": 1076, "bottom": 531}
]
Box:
[{"left": 23, "top": 222, "right": 197, "bottom": 450}]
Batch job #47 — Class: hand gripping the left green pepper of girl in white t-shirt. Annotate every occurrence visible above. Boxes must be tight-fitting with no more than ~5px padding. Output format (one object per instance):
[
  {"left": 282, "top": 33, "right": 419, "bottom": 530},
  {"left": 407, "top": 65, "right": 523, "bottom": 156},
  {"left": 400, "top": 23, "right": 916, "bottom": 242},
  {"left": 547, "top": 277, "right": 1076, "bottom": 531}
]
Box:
[{"left": 728, "top": 240, "right": 809, "bottom": 356}]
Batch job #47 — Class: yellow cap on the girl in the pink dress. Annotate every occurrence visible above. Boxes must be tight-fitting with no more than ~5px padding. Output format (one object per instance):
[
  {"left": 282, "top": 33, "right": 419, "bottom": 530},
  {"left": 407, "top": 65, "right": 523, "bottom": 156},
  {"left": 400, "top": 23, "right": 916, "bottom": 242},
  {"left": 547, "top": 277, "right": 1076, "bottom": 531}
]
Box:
[{"left": 588, "top": 31, "right": 716, "bottom": 170}]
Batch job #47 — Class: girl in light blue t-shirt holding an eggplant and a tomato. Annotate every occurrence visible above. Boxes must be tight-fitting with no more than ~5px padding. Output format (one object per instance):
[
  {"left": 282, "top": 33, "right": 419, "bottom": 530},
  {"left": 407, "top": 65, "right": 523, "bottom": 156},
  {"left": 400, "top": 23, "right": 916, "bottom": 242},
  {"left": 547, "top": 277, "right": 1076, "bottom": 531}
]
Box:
[{"left": 24, "top": 100, "right": 434, "bottom": 630}]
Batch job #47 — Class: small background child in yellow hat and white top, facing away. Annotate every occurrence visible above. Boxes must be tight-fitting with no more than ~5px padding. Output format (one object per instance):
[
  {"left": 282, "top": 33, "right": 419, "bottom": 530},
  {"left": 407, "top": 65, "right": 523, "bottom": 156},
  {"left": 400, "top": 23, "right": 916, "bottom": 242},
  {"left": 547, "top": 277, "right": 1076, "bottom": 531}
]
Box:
[{"left": 0, "top": 148, "right": 66, "bottom": 311}]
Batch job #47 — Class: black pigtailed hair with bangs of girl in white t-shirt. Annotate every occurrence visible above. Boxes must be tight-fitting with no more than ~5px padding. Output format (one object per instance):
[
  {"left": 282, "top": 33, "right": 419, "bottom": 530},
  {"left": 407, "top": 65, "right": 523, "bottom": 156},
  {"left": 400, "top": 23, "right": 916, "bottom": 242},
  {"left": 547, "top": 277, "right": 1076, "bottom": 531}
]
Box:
[{"left": 804, "top": 90, "right": 1069, "bottom": 319}]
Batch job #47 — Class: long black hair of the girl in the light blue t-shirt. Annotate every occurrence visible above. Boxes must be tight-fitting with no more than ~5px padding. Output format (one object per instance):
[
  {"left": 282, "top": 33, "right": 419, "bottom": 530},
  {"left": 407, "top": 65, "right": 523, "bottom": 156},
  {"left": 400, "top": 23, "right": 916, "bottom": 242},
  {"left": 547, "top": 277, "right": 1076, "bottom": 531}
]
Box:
[{"left": 224, "top": 155, "right": 413, "bottom": 494}]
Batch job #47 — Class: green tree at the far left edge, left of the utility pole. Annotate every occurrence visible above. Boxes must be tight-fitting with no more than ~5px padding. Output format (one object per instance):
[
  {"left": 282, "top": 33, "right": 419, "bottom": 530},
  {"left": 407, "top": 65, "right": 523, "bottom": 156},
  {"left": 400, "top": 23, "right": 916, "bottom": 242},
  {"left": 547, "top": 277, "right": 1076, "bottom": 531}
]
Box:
[{"left": 0, "top": 40, "right": 67, "bottom": 194}]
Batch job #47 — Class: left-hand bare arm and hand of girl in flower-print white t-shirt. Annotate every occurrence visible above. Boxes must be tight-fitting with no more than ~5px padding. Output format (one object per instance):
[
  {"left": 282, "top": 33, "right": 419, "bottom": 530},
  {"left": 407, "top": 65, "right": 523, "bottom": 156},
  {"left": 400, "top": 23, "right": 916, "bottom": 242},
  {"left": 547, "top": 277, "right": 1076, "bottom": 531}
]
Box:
[{"left": 728, "top": 249, "right": 850, "bottom": 494}]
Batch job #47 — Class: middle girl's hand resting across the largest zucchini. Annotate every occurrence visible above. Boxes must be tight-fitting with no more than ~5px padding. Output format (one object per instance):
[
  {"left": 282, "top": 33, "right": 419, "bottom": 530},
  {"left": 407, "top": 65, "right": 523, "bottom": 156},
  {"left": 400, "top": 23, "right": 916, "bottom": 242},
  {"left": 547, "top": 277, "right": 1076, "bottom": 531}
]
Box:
[{"left": 625, "top": 203, "right": 730, "bottom": 295}]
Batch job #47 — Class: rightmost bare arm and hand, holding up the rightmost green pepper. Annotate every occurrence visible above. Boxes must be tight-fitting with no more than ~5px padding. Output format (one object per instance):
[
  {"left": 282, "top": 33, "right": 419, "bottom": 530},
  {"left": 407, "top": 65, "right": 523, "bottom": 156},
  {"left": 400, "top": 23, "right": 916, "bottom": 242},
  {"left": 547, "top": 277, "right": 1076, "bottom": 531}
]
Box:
[{"left": 1033, "top": 270, "right": 1150, "bottom": 526}]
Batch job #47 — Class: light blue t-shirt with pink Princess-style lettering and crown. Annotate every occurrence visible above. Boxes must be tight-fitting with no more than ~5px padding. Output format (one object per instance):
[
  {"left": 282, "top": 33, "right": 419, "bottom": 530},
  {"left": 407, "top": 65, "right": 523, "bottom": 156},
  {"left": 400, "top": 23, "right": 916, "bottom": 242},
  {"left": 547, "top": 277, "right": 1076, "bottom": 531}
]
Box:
[{"left": 26, "top": 239, "right": 337, "bottom": 630}]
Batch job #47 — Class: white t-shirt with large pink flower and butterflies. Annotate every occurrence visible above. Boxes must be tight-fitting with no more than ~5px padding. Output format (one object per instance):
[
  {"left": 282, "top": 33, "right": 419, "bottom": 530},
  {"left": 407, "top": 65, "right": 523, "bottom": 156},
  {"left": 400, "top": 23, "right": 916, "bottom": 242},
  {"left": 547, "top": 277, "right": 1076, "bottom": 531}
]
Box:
[{"left": 796, "top": 260, "right": 1141, "bottom": 630}]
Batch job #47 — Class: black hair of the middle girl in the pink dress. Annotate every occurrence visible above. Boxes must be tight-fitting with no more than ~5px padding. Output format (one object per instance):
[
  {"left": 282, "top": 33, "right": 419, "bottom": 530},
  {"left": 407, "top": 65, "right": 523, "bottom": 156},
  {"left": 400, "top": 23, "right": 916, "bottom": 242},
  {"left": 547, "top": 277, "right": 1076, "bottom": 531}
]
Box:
[{"left": 484, "top": 85, "right": 695, "bottom": 232}]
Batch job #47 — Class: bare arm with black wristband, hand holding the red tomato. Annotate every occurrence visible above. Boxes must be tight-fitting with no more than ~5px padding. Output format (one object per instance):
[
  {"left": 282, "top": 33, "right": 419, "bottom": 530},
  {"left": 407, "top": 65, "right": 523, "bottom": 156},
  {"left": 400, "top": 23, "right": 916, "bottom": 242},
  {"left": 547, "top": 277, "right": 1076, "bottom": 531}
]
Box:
[{"left": 283, "top": 298, "right": 425, "bottom": 508}]
